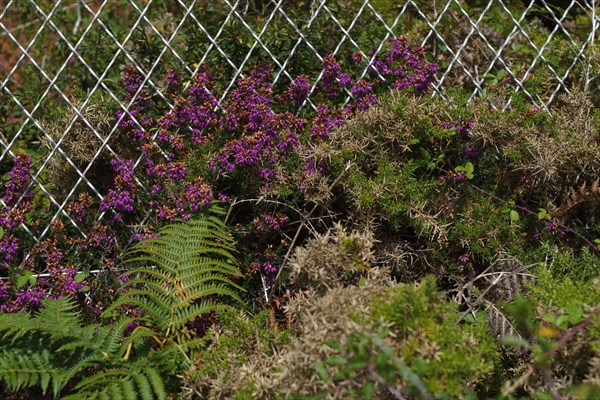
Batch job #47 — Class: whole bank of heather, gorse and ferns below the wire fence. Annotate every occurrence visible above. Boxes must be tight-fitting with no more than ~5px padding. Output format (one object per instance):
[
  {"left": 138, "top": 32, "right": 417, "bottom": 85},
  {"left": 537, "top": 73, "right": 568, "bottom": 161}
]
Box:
[{"left": 0, "top": 2, "right": 600, "bottom": 399}]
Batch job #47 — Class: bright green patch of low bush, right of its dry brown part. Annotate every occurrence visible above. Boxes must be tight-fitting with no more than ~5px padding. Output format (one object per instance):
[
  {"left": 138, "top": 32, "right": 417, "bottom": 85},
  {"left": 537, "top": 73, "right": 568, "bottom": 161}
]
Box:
[{"left": 342, "top": 278, "right": 499, "bottom": 398}]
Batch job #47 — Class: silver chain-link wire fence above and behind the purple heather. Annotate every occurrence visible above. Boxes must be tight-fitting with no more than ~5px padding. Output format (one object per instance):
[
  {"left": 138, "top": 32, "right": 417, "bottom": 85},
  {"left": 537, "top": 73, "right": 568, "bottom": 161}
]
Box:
[{"left": 0, "top": 0, "right": 600, "bottom": 262}]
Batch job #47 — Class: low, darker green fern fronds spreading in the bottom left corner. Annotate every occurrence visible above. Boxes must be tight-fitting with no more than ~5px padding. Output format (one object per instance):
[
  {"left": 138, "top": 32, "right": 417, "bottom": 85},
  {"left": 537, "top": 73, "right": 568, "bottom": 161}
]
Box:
[{"left": 0, "top": 298, "right": 167, "bottom": 400}]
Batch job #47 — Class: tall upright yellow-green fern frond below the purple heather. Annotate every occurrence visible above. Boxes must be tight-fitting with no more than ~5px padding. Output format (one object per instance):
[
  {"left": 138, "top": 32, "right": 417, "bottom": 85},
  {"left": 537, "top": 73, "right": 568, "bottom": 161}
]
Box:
[{"left": 105, "top": 211, "right": 243, "bottom": 342}]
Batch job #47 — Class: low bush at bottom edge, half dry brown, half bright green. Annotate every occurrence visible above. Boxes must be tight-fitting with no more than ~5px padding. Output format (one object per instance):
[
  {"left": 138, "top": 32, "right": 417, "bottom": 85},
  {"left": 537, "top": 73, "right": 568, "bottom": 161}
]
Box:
[{"left": 185, "top": 271, "right": 499, "bottom": 399}]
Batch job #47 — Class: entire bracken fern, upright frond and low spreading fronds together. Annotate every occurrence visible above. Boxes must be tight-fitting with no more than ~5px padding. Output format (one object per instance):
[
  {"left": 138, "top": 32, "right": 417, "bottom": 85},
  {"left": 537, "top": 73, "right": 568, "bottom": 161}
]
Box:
[{"left": 0, "top": 211, "right": 241, "bottom": 400}]
